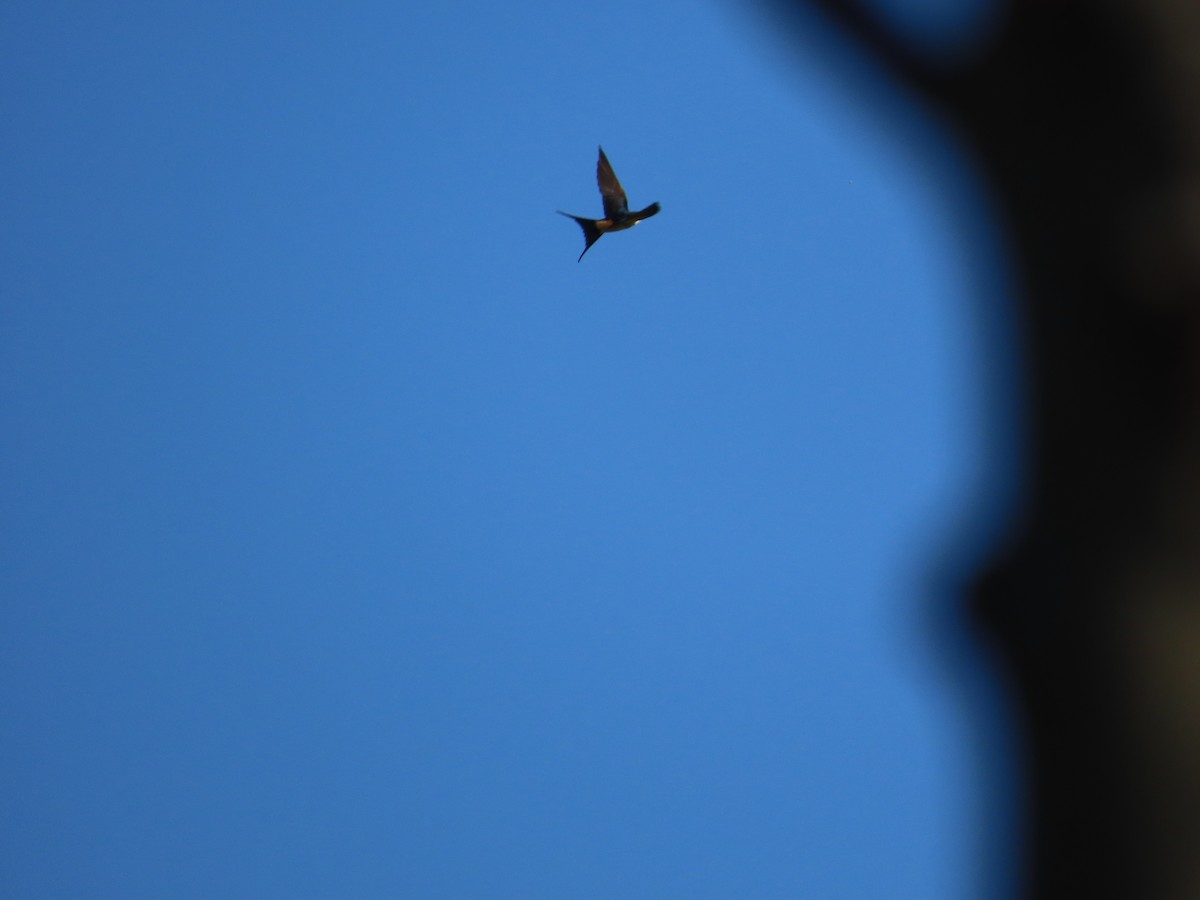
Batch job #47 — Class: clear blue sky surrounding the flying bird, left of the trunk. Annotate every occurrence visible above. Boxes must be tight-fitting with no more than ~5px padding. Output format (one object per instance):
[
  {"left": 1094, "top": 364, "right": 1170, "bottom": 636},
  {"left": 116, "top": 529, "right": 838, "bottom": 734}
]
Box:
[{"left": 0, "top": 0, "right": 1012, "bottom": 900}]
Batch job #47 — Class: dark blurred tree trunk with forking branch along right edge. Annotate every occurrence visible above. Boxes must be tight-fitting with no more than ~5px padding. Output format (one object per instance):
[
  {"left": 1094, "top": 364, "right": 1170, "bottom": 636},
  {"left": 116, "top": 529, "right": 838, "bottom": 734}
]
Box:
[{"left": 781, "top": 0, "right": 1200, "bottom": 900}]
